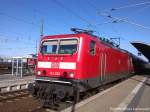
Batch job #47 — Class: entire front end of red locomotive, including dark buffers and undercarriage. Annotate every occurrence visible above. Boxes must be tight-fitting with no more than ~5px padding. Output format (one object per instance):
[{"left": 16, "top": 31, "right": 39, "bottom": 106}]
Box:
[{"left": 28, "top": 34, "right": 83, "bottom": 106}]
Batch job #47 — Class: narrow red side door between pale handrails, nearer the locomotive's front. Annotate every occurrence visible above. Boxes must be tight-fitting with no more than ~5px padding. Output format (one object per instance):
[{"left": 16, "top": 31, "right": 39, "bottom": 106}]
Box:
[{"left": 100, "top": 53, "right": 106, "bottom": 81}]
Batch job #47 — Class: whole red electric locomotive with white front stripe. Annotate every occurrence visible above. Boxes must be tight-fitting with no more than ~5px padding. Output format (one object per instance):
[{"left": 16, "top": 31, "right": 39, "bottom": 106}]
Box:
[{"left": 28, "top": 29, "right": 133, "bottom": 107}]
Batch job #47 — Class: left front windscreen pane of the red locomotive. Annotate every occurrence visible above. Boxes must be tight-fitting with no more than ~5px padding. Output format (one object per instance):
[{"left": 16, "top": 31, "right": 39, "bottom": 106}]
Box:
[{"left": 41, "top": 40, "right": 58, "bottom": 54}]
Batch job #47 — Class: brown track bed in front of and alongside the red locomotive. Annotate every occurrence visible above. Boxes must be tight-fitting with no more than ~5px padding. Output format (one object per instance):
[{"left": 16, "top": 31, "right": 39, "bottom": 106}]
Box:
[{"left": 0, "top": 76, "right": 127, "bottom": 112}]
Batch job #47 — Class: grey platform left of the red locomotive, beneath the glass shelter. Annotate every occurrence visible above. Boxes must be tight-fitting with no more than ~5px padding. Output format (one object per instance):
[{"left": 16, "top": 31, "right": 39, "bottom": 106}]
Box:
[{"left": 0, "top": 74, "right": 35, "bottom": 88}]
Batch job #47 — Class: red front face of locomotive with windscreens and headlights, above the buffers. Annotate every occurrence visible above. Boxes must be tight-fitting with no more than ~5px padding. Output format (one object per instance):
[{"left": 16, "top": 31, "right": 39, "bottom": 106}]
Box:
[{"left": 37, "top": 38, "right": 78, "bottom": 78}]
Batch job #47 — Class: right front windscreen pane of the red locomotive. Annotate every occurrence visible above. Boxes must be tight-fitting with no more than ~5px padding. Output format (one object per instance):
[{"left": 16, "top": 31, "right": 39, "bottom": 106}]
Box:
[{"left": 58, "top": 39, "right": 78, "bottom": 54}]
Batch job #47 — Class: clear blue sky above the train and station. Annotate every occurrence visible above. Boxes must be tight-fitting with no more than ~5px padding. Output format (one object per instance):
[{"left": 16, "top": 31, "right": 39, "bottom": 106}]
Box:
[{"left": 0, "top": 0, "right": 150, "bottom": 60}]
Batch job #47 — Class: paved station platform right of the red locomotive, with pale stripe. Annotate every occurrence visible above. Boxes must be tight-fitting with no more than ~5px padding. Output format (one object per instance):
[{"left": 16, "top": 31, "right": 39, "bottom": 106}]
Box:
[{"left": 62, "top": 75, "right": 150, "bottom": 112}]
